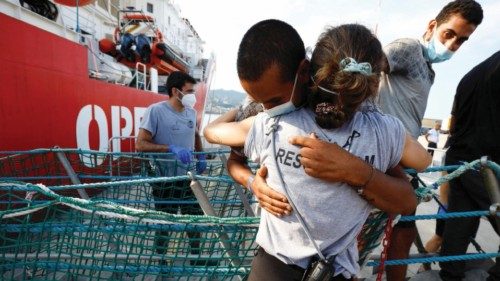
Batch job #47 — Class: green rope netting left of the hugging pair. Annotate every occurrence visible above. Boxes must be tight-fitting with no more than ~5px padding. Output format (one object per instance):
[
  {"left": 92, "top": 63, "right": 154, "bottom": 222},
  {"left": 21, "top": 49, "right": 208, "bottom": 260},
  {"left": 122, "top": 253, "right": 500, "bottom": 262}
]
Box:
[{"left": 0, "top": 150, "right": 257, "bottom": 280}]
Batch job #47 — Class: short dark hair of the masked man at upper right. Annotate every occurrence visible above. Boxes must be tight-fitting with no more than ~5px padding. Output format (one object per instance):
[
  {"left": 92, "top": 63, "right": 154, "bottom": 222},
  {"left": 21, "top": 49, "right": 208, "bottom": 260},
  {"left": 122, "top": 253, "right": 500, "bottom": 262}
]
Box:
[{"left": 436, "top": 0, "right": 483, "bottom": 26}]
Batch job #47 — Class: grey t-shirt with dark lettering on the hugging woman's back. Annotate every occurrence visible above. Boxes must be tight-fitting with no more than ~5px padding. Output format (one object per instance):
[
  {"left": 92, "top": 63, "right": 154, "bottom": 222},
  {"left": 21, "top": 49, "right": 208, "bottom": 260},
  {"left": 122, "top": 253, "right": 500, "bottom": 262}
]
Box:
[{"left": 245, "top": 107, "right": 405, "bottom": 277}]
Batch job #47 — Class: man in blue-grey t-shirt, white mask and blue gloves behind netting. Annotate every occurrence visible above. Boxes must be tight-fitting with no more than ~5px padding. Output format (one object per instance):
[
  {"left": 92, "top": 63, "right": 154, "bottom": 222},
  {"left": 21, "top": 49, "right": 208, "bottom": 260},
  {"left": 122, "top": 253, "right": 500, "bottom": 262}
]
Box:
[{"left": 136, "top": 71, "right": 206, "bottom": 264}]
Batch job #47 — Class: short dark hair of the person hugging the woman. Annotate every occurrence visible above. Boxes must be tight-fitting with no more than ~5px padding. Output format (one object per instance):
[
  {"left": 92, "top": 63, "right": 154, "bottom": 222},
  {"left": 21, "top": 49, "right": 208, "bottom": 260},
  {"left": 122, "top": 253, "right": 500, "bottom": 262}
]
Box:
[{"left": 236, "top": 19, "right": 306, "bottom": 82}]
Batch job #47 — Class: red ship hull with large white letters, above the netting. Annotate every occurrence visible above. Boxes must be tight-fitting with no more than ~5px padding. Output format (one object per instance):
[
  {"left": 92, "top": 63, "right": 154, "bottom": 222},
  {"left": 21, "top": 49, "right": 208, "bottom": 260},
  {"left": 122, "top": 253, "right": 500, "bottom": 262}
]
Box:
[{"left": 0, "top": 13, "right": 208, "bottom": 151}]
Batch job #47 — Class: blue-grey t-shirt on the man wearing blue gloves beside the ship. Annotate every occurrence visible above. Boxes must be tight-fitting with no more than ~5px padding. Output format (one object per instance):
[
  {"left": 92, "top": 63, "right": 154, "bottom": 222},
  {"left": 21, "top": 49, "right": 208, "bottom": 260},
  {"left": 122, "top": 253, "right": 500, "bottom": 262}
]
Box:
[{"left": 140, "top": 101, "right": 196, "bottom": 176}]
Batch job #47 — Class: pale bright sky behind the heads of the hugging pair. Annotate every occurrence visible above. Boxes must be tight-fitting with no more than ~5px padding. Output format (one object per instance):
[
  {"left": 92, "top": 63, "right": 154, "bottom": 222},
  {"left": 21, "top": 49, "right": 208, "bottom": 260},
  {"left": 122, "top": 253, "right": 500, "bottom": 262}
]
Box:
[{"left": 180, "top": 0, "right": 500, "bottom": 119}]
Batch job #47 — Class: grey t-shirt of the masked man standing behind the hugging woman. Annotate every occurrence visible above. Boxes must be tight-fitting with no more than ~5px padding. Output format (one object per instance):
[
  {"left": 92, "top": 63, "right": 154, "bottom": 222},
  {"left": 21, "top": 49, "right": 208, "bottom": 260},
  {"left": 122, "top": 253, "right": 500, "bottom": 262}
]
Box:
[{"left": 378, "top": 38, "right": 435, "bottom": 138}]
